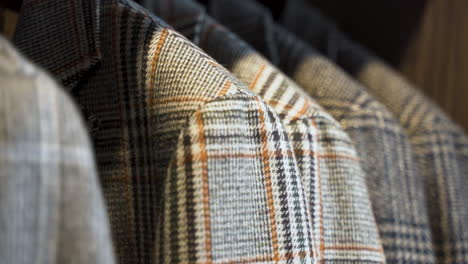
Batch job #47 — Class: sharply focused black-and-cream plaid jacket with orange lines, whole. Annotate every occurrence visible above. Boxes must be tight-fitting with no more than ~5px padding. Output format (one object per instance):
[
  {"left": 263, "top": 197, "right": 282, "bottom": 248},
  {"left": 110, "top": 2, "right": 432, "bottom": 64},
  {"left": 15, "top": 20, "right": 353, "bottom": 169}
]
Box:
[{"left": 11, "top": 0, "right": 313, "bottom": 263}]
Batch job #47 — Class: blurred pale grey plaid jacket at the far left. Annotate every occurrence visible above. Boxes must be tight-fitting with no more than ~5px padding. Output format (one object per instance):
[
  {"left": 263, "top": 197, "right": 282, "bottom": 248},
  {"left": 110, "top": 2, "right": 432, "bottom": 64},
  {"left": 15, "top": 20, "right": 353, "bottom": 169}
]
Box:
[{"left": 0, "top": 36, "right": 115, "bottom": 264}]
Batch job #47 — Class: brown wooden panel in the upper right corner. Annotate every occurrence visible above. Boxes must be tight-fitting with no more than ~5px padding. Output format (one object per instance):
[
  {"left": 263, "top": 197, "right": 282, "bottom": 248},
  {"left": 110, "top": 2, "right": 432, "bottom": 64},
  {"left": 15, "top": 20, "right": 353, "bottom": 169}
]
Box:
[{"left": 401, "top": 0, "right": 468, "bottom": 131}]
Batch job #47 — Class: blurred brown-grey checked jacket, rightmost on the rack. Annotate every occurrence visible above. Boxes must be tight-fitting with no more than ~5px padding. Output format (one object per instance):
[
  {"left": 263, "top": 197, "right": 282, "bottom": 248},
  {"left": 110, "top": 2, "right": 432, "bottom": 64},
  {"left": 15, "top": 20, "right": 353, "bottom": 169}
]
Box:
[{"left": 283, "top": 0, "right": 468, "bottom": 263}]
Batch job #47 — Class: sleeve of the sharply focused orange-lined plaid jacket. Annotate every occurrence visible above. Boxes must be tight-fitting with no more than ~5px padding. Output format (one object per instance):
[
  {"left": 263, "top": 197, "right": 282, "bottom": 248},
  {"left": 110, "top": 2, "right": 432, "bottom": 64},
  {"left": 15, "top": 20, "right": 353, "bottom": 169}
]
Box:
[{"left": 156, "top": 93, "right": 312, "bottom": 263}]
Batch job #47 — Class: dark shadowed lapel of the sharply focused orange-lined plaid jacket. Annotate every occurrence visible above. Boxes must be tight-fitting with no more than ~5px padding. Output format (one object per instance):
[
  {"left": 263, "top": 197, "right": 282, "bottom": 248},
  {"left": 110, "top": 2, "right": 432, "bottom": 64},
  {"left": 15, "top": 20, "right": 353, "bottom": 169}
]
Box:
[{"left": 13, "top": 0, "right": 101, "bottom": 91}]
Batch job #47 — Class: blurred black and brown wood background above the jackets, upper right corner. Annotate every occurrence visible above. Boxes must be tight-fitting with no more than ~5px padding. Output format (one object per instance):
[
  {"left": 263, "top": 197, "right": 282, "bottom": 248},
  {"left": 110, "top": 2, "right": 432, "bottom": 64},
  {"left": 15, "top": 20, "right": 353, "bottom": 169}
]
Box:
[{"left": 313, "top": 0, "right": 468, "bottom": 131}]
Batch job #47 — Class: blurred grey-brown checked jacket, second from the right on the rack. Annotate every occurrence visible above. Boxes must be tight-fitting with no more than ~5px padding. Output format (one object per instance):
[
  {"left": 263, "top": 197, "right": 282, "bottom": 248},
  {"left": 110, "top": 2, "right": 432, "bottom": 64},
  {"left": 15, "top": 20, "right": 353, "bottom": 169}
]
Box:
[{"left": 211, "top": 0, "right": 434, "bottom": 263}]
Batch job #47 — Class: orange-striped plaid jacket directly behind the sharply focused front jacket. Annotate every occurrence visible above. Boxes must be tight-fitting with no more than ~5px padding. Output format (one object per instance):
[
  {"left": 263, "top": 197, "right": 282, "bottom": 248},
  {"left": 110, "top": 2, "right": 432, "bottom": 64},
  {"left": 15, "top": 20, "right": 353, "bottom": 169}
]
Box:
[{"left": 146, "top": 0, "right": 385, "bottom": 263}]
